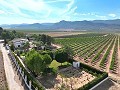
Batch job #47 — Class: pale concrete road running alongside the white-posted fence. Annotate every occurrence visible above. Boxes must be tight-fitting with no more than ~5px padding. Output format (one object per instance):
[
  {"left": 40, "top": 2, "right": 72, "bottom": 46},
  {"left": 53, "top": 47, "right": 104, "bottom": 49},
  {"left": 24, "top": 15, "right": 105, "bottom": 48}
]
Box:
[{"left": 0, "top": 43, "right": 24, "bottom": 90}]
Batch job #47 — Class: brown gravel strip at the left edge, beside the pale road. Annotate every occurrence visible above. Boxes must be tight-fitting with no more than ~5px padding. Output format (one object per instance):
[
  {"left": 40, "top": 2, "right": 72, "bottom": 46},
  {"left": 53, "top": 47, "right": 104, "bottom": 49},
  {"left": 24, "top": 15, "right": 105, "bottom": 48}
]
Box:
[{"left": 0, "top": 51, "right": 8, "bottom": 90}]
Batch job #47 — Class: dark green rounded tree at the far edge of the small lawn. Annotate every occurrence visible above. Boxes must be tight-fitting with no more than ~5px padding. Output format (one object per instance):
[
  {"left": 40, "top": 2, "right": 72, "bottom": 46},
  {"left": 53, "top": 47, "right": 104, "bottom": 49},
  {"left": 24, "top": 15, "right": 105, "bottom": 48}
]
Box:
[{"left": 55, "top": 50, "right": 68, "bottom": 64}]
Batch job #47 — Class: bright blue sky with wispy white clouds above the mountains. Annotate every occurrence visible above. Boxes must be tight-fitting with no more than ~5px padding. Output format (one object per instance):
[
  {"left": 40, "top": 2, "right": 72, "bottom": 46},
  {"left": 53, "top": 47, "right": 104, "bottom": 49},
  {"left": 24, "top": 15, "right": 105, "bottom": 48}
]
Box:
[{"left": 0, "top": 0, "right": 120, "bottom": 24}]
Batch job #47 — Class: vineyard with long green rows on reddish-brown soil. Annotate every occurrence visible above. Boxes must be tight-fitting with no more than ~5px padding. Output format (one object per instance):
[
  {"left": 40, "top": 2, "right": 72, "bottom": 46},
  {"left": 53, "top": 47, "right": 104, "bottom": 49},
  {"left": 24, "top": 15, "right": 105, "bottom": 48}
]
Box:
[{"left": 55, "top": 33, "right": 120, "bottom": 74}]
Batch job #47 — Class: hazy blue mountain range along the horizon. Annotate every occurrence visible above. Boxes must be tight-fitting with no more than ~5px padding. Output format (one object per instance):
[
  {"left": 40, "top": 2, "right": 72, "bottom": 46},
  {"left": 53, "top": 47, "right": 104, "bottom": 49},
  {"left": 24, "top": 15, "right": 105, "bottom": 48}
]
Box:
[{"left": 0, "top": 19, "right": 120, "bottom": 31}]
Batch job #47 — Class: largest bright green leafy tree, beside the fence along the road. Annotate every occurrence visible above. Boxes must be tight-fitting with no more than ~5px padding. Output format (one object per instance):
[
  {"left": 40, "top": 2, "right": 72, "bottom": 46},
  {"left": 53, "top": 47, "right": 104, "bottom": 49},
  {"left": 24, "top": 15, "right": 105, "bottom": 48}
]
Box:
[{"left": 25, "top": 50, "right": 45, "bottom": 75}]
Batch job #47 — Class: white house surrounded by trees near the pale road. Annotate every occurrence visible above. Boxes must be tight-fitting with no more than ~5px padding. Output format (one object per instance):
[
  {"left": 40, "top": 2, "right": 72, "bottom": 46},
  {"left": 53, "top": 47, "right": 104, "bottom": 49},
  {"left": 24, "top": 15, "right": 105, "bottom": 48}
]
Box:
[{"left": 12, "top": 38, "right": 28, "bottom": 48}]
